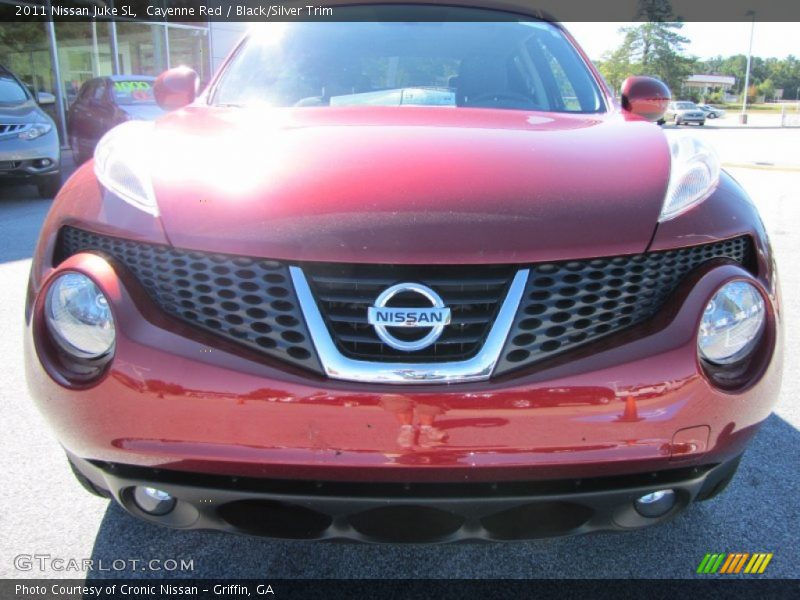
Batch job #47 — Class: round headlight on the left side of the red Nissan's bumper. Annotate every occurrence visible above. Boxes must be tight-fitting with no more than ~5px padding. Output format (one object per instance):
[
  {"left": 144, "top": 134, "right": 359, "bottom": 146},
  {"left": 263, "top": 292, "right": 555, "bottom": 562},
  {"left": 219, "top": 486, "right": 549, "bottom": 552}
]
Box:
[{"left": 45, "top": 273, "right": 116, "bottom": 359}]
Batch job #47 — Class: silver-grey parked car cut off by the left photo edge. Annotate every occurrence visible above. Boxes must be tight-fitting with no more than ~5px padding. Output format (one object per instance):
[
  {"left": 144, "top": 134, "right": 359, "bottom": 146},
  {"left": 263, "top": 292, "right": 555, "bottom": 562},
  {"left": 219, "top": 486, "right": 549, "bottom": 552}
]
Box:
[{"left": 0, "top": 65, "right": 61, "bottom": 198}]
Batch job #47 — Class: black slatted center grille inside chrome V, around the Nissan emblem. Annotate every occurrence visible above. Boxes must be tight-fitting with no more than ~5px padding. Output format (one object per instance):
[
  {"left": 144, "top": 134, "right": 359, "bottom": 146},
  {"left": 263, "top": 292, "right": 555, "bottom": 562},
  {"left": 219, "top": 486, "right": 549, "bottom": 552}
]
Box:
[{"left": 303, "top": 264, "right": 516, "bottom": 363}]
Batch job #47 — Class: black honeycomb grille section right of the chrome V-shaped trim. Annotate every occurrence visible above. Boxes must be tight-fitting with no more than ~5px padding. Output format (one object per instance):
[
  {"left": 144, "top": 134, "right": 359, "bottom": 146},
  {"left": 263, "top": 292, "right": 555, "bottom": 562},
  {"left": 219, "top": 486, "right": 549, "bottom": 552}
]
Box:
[{"left": 495, "top": 237, "right": 754, "bottom": 375}]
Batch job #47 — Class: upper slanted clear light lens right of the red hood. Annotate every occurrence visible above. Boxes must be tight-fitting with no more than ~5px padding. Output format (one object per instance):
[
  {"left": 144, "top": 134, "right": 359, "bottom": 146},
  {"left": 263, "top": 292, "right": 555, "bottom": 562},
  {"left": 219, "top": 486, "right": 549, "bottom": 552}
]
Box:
[{"left": 659, "top": 136, "right": 720, "bottom": 221}]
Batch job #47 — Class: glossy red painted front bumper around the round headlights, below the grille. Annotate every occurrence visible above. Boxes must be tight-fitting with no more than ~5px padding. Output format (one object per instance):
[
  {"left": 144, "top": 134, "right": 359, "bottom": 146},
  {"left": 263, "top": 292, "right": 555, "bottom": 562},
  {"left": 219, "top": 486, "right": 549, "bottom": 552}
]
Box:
[{"left": 26, "top": 246, "right": 781, "bottom": 483}]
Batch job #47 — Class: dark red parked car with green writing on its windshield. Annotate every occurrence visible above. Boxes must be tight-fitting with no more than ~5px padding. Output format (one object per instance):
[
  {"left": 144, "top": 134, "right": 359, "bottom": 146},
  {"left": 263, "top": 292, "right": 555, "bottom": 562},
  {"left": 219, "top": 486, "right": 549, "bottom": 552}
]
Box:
[{"left": 67, "top": 75, "right": 164, "bottom": 163}]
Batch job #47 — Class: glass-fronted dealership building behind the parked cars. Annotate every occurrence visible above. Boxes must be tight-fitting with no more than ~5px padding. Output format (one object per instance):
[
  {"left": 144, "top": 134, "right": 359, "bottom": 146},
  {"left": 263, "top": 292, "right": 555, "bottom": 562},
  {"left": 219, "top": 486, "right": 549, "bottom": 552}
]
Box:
[{"left": 0, "top": 0, "right": 246, "bottom": 141}]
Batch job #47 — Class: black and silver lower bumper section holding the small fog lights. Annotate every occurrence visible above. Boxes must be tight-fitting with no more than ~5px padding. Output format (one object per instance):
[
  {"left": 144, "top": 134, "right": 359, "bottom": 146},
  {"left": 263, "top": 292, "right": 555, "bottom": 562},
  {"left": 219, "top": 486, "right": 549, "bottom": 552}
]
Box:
[{"left": 71, "top": 457, "right": 739, "bottom": 543}]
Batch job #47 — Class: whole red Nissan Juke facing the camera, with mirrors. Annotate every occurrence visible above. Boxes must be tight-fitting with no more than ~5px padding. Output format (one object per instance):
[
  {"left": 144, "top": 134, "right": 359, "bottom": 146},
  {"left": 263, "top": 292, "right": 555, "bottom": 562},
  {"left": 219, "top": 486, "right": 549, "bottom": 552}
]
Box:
[{"left": 25, "top": 3, "right": 782, "bottom": 542}]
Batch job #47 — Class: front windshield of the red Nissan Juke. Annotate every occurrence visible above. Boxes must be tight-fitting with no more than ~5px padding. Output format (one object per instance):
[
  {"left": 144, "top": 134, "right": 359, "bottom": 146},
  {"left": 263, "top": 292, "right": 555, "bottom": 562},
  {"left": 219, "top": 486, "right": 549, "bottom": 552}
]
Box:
[{"left": 211, "top": 9, "right": 604, "bottom": 113}]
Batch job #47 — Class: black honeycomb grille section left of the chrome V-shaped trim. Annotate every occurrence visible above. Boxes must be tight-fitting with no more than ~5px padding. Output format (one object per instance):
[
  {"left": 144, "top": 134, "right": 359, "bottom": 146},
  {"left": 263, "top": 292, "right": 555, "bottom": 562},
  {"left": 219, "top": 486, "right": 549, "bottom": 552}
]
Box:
[{"left": 57, "top": 227, "right": 322, "bottom": 373}]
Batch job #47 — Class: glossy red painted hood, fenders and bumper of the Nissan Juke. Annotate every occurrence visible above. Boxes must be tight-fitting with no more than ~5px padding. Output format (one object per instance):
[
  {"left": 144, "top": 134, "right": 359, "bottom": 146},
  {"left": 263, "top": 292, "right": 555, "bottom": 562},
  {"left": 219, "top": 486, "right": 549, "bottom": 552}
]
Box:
[{"left": 25, "top": 4, "right": 783, "bottom": 528}]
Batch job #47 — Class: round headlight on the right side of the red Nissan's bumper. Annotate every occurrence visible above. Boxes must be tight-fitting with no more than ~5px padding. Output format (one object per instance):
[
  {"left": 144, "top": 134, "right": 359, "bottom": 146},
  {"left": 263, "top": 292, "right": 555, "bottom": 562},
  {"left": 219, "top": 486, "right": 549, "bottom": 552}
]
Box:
[{"left": 697, "top": 281, "right": 765, "bottom": 365}]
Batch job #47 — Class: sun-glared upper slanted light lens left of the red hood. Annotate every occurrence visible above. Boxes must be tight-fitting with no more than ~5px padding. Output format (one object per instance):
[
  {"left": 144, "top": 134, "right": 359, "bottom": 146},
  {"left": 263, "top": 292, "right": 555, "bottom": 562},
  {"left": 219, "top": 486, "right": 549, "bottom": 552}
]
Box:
[{"left": 94, "top": 121, "right": 159, "bottom": 217}]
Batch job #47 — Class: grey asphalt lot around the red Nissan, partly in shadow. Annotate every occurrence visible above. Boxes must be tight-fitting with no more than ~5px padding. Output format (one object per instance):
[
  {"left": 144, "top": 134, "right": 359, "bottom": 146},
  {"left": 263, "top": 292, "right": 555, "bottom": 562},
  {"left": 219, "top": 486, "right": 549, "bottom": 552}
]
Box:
[{"left": 0, "top": 127, "right": 800, "bottom": 578}]
